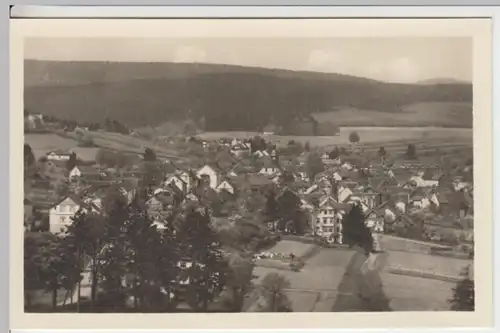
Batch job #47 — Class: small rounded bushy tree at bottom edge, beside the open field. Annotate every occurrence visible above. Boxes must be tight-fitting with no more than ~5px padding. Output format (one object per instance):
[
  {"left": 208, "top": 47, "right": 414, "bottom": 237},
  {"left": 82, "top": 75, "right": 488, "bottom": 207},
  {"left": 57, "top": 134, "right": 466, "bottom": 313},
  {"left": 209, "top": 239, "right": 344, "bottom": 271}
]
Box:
[{"left": 259, "top": 273, "right": 291, "bottom": 312}]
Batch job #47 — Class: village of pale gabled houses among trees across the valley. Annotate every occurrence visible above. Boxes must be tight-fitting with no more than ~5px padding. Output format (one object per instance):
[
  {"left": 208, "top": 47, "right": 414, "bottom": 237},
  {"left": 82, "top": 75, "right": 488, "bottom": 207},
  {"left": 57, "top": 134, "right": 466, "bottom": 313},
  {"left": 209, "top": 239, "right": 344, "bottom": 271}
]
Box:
[{"left": 24, "top": 118, "right": 474, "bottom": 311}]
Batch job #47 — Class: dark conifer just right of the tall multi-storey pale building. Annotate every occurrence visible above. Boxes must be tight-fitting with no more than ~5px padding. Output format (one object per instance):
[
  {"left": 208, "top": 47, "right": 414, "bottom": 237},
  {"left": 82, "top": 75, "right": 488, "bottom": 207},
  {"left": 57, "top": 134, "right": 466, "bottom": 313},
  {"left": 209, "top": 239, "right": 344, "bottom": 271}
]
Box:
[{"left": 342, "top": 204, "right": 373, "bottom": 253}]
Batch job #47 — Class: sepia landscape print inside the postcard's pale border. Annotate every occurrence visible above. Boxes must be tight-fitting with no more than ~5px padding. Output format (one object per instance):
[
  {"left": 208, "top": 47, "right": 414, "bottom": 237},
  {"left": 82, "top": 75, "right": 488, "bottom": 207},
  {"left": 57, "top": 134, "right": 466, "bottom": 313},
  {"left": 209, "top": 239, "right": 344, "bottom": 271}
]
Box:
[{"left": 13, "top": 16, "right": 494, "bottom": 326}]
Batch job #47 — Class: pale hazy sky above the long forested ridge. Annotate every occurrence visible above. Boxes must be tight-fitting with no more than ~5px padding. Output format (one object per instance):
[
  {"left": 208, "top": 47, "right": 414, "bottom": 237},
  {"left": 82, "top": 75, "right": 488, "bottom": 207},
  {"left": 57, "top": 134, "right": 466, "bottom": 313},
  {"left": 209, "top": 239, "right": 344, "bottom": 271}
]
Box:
[{"left": 24, "top": 37, "right": 472, "bottom": 83}]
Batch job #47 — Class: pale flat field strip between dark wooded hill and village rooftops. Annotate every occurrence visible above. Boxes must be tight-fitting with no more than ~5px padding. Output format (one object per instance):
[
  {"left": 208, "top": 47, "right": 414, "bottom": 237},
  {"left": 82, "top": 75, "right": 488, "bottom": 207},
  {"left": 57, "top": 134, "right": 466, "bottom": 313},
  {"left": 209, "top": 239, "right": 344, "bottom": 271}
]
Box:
[{"left": 200, "top": 127, "right": 472, "bottom": 150}]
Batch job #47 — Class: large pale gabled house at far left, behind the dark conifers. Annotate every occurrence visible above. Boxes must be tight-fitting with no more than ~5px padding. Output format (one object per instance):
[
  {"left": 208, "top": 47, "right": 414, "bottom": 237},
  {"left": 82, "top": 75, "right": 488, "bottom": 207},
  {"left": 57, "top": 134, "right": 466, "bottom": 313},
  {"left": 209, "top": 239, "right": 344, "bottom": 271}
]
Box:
[{"left": 49, "top": 196, "right": 99, "bottom": 234}]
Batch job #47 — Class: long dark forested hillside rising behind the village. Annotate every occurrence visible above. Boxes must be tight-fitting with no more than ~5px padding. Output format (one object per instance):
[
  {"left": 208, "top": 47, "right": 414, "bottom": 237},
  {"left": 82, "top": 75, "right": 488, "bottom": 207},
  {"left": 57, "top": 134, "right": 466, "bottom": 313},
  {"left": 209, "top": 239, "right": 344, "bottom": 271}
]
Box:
[{"left": 24, "top": 60, "right": 472, "bottom": 131}]
